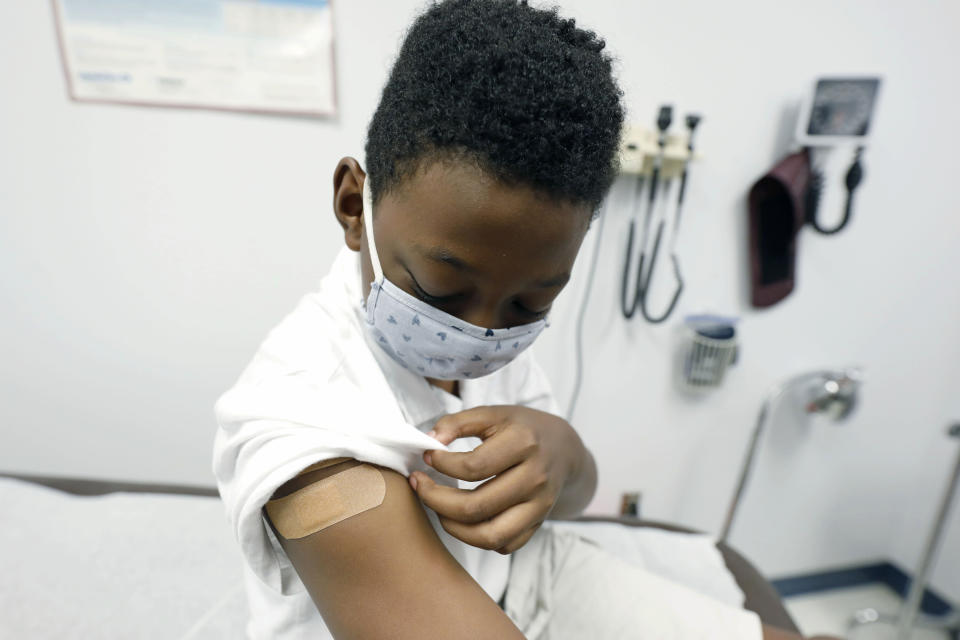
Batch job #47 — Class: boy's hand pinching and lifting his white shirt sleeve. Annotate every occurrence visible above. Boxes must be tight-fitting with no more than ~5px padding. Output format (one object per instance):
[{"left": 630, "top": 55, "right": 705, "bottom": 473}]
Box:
[{"left": 410, "top": 406, "right": 585, "bottom": 554}]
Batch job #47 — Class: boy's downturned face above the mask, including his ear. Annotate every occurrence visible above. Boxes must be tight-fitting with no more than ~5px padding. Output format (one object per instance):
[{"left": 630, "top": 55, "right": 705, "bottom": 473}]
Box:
[{"left": 334, "top": 158, "right": 590, "bottom": 329}]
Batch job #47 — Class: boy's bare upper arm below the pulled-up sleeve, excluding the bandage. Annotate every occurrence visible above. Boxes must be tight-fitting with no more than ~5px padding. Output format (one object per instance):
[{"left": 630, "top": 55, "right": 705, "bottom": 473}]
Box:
[{"left": 264, "top": 459, "right": 523, "bottom": 640}]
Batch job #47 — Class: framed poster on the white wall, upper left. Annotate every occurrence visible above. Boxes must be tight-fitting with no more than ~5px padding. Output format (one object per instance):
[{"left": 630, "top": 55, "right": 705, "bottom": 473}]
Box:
[{"left": 52, "top": 0, "right": 337, "bottom": 117}]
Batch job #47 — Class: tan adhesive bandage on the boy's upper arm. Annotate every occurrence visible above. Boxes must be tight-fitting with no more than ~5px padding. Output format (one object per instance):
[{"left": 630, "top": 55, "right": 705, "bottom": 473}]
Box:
[{"left": 266, "top": 462, "right": 386, "bottom": 540}]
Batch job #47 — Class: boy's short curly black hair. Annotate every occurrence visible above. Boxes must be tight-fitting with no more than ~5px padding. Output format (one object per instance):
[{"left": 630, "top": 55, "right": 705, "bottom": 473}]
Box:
[{"left": 365, "top": 0, "right": 624, "bottom": 214}]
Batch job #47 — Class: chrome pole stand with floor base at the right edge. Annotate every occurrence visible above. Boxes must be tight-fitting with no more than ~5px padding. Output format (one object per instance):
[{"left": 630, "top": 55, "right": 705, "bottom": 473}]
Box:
[{"left": 848, "top": 423, "right": 960, "bottom": 640}]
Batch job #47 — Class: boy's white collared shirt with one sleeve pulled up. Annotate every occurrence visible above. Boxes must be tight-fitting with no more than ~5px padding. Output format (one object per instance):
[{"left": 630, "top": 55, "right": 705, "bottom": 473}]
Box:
[{"left": 213, "top": 248, "right": 559, "bottom": 640}]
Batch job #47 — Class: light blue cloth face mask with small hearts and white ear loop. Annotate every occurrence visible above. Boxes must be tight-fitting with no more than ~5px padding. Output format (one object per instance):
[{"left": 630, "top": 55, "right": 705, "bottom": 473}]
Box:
[{"left": 363, "top": 180, "right": 547, "bottom": 380}]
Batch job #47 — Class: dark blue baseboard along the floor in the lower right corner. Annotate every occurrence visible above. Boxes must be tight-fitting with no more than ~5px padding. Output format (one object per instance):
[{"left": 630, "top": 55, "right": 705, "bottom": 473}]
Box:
[{"left": 770, "top": 562, "right": 953, "bottom": 615}]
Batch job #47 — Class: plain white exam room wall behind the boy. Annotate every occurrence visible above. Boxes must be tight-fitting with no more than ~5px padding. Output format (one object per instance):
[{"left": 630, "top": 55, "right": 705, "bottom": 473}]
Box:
[{"left": 0, "top": 0, "right": 960, "bottom": 598}]
